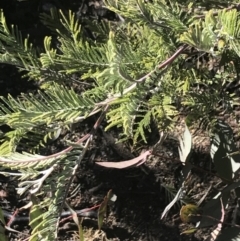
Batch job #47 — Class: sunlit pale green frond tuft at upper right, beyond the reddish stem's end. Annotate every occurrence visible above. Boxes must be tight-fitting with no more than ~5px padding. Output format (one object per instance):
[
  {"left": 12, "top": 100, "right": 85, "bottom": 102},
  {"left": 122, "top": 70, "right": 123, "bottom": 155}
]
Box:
[{"left": 180, "top": 9, "right": 240, "bottom": 54}]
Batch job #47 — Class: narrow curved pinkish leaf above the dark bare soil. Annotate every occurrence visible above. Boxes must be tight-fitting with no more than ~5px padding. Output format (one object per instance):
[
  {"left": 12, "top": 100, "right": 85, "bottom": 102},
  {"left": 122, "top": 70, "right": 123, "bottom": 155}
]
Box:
[{"left": 96, "top": 150, "right": 152, "bottom": 169}]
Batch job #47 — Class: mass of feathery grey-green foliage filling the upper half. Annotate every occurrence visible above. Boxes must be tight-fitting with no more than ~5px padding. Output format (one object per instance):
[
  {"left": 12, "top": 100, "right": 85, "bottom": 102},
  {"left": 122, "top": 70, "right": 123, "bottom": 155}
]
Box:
[{"left": 0, "top": 1, "right": 239, "bottom": 149}]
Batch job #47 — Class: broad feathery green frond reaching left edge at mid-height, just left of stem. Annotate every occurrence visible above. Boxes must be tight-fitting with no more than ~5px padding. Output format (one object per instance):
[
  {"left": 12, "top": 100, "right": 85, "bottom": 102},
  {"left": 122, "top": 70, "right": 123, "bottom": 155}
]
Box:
[{"left": 0, "top": 84, "right": 94, "bottom": 129}]
